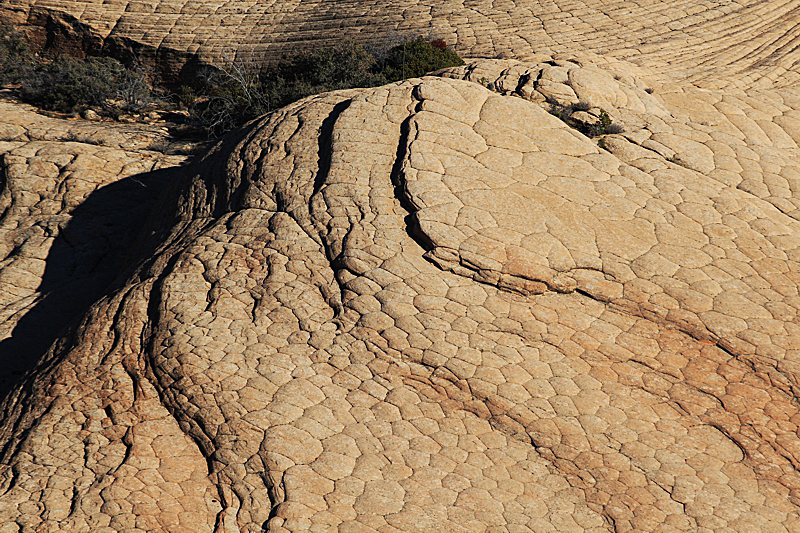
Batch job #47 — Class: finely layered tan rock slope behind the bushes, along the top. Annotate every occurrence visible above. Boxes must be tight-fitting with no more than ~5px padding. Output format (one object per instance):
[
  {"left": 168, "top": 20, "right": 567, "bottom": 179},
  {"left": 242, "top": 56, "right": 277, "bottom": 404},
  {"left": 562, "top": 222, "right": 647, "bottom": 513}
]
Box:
[{"left": 0, "top": 0, "right": 800, "bottom": 87}]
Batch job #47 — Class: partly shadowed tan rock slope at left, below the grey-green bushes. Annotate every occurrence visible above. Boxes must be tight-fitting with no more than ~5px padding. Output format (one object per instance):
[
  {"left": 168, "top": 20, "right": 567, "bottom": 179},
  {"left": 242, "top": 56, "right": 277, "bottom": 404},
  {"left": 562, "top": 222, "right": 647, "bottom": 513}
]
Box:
[{"left": 0, "top": 101, "right": 185, "bottom": 394}]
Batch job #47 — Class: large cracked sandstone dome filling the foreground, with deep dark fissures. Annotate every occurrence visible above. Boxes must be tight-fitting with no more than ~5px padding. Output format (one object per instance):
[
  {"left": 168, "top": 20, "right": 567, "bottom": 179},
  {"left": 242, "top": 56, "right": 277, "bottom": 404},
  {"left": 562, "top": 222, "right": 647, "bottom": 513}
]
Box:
[{"left": 0, "top": 51, "right": 800, "bottom": 533}]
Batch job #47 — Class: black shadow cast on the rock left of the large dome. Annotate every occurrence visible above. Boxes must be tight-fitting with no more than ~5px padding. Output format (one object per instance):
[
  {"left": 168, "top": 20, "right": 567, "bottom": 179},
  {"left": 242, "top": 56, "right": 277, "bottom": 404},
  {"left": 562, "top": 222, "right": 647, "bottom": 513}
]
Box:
[{"left": 0, "top": 167, "right": 183, "bottom": 402}]
